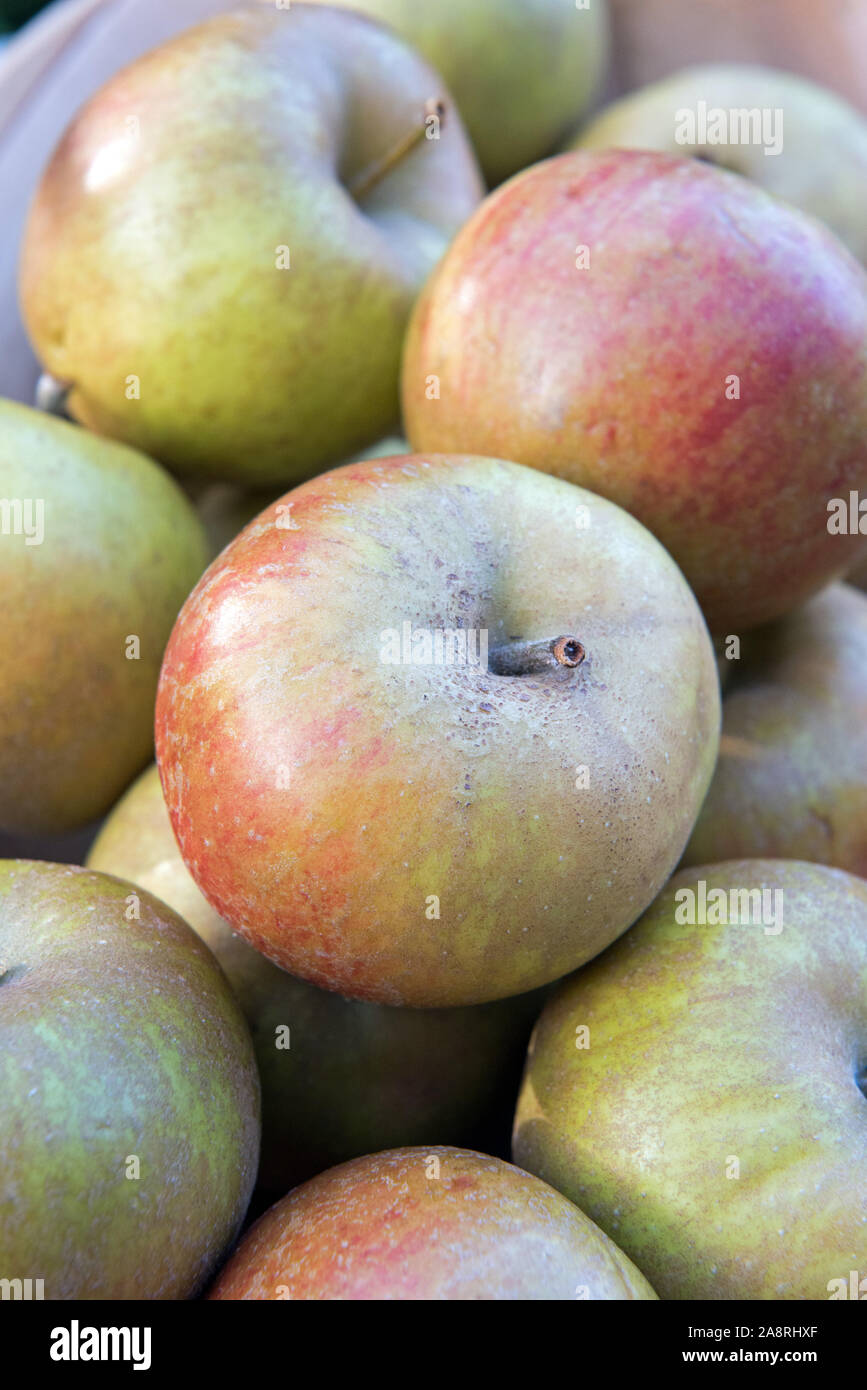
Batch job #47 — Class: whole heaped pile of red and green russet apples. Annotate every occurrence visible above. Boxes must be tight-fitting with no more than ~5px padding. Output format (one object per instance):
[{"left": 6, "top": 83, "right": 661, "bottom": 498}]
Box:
[{"left": 0, "top": 0, "right": 867, "bottom": 1300}]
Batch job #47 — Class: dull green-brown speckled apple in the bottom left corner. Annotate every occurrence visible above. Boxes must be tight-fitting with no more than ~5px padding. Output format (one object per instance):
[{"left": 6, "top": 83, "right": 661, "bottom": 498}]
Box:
[{"left": 0, "top": 859, "right": 258, "bottom": 1300}]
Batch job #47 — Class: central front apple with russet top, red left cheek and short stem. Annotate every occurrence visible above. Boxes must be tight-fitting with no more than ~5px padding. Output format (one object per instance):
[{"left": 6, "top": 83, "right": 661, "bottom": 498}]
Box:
[{"left": 156, "top": 456, "right": 720, "bottom": 1008}]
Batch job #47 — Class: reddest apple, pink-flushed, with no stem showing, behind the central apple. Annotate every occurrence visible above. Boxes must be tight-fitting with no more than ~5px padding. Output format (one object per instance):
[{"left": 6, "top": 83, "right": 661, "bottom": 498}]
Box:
[{"left": 403, "top": 150, "right": 867, "bottom": 634}]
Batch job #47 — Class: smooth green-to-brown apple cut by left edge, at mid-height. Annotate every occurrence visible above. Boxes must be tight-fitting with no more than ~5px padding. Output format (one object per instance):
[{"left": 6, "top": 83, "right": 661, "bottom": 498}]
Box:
[{"left": 0, "top": 402, "right": 206, "bottom": 833}]
